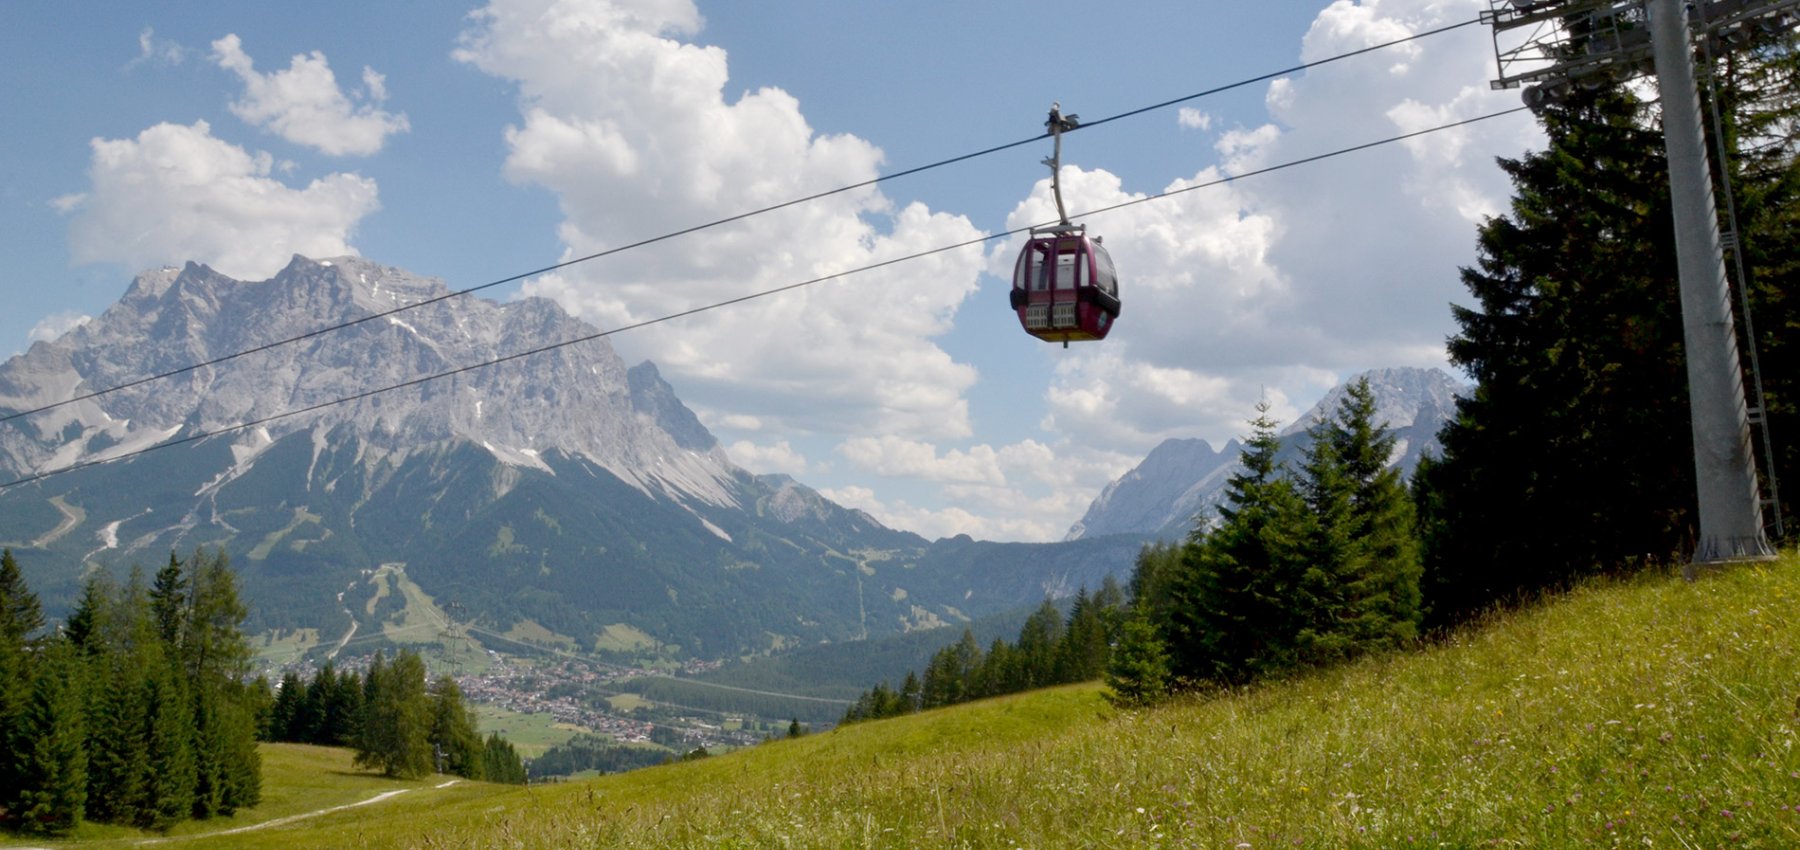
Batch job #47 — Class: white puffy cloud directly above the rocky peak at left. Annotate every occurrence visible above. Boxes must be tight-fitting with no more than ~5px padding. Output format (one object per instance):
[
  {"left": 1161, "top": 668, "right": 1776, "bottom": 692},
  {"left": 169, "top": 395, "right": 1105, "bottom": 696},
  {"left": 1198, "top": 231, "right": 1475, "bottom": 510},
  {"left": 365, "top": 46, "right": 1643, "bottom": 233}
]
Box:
[{"left": 58, "top": 121, "right": 378, "bottom": 279}]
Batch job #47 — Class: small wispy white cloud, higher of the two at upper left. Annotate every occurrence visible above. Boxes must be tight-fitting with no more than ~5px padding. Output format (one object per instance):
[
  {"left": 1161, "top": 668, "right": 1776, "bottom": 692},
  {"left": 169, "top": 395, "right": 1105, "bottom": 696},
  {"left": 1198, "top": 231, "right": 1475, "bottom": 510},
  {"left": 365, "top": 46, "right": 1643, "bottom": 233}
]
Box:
[{"left": 212, "top": 34, "right": 409, "bottom": 157}]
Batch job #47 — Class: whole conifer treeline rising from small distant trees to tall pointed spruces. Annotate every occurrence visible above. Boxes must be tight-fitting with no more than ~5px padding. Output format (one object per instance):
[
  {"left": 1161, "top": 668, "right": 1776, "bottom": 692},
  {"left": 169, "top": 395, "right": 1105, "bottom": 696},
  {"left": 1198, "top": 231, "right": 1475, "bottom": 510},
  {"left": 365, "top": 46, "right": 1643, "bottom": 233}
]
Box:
[{"left": 844, "top": 380, "right": 1422, "bottom": 722}]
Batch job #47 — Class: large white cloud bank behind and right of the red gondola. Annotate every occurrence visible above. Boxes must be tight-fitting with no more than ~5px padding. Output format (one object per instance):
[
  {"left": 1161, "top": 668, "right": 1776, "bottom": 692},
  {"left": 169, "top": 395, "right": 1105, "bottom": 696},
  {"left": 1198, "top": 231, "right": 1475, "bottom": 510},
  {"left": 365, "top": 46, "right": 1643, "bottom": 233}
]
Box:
[{"left": 1008, "top": 0, "right": 1541, "bottom": 464}]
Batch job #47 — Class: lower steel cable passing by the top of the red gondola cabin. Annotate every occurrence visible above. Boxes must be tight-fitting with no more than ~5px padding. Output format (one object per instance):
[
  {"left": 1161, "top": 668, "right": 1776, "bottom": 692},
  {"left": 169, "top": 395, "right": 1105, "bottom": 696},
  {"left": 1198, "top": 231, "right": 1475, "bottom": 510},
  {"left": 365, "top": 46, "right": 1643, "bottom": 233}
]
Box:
[{"left": 0, "top": 106, "right": 1528, "bottom": 490}]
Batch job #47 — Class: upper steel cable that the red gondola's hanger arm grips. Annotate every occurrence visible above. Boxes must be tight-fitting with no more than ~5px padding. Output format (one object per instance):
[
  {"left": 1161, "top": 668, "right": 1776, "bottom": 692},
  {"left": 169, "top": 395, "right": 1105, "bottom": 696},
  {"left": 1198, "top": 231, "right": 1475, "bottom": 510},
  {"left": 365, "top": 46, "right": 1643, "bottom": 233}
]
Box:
[{"left": 0, "top": 18, "right": 1481, "bottom": 423}]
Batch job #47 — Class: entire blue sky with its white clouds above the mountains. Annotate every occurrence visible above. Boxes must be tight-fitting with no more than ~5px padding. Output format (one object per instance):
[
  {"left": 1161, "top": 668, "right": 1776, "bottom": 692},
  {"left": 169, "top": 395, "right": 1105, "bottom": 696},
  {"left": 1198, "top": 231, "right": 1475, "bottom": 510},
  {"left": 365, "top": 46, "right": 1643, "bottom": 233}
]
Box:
[{"left": 0, "top": 0, "right": 1541, "bottom": 540}]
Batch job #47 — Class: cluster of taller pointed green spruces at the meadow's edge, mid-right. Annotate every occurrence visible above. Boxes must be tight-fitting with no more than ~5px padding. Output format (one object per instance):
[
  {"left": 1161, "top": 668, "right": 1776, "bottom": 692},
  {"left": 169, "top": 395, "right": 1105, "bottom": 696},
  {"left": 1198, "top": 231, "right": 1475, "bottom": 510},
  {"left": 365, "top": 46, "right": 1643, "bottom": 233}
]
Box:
[{"left": 1109, "top": 378, "right": 1422, "bottom": 702}]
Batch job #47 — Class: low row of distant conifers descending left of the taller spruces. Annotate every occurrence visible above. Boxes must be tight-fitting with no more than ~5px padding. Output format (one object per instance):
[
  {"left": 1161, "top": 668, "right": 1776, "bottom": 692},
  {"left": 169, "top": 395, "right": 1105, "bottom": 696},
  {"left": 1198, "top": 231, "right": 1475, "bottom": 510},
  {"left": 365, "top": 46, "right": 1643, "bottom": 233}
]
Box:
[{"left": 842, "top": 576, "right": 1125, "bottom": 724}]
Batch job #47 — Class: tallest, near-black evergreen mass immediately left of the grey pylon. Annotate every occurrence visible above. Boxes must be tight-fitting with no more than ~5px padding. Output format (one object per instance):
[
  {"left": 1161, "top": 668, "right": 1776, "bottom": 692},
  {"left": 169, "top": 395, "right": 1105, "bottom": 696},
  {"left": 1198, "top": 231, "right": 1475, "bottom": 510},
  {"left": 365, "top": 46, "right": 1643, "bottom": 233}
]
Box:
[{"left": 1420, "top": 82, "right": 1694, "bottom": 623}]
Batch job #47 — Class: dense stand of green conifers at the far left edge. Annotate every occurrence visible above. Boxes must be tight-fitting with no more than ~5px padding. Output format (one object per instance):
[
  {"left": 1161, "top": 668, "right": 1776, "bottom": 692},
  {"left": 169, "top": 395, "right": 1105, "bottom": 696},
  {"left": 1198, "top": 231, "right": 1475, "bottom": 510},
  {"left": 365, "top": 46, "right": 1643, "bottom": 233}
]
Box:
[{"left": 0, "top": 549, "right": 266, "bottom": 834}]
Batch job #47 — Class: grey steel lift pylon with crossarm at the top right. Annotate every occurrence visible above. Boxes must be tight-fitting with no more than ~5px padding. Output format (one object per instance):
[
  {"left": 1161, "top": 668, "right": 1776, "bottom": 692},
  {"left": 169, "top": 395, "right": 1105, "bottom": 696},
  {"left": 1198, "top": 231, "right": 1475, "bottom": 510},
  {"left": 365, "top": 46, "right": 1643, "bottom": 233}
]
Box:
[{"left": 1481, "top": 0, "right": 1800, "bottom": 574}]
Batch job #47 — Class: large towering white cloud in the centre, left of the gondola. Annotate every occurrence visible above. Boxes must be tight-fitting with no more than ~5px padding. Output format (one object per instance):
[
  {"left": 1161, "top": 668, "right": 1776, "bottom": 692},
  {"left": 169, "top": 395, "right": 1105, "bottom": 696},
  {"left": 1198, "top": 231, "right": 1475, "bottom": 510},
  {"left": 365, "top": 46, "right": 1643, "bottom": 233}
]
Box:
[{"left": 455, "top": 0, "right": 983, "bottom": 438}]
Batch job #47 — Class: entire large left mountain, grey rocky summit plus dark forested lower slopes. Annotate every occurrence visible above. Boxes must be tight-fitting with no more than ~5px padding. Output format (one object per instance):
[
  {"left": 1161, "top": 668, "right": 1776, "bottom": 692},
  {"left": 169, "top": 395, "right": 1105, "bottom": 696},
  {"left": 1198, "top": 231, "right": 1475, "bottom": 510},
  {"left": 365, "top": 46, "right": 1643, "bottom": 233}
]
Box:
[{"left": 0, "top": 258, "right": 1141, "bottom": 657}]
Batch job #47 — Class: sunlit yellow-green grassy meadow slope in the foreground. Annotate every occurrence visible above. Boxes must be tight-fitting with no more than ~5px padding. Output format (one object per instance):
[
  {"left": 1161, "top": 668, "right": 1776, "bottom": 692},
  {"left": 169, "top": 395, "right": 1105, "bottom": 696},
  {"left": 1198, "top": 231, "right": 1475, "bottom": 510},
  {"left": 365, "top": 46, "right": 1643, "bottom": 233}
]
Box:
[{"left": 17, "top": 556, "right": 1800, "bottom": 848}]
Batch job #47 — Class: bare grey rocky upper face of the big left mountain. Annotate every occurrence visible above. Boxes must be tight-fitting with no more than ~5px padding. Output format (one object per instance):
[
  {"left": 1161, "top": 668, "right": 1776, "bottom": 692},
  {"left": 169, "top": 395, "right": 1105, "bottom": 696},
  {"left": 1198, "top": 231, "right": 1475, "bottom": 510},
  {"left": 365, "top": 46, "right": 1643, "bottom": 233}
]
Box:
[{"left": 0, "top": 258, "right": 738, "bottom": 504}]
